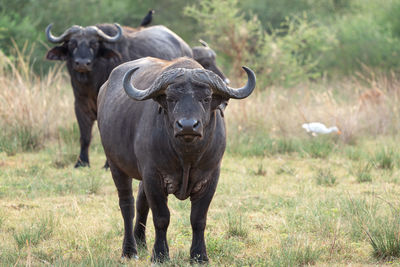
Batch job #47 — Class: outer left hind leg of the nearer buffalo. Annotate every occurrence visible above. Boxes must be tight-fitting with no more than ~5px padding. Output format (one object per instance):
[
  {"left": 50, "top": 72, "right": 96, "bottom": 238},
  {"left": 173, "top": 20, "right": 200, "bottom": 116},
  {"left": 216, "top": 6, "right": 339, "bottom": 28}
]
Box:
[{"left": 110, "top": 164, "right": 138, "bottom": 259}]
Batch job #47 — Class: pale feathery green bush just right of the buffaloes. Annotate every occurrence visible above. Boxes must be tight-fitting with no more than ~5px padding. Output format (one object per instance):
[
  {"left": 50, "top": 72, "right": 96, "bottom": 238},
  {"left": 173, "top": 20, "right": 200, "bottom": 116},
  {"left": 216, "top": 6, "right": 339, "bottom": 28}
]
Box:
[{"left": 252, "top": 15, "right": 337, "bottom": 86}]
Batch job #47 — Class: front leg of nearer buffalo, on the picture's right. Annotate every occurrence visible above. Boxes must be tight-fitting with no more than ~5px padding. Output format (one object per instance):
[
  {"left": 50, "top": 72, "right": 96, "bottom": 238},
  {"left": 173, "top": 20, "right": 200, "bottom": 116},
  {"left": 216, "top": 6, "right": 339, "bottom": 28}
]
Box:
[{"left": 190, "top": 174, "right": 219, "bottom": 263}]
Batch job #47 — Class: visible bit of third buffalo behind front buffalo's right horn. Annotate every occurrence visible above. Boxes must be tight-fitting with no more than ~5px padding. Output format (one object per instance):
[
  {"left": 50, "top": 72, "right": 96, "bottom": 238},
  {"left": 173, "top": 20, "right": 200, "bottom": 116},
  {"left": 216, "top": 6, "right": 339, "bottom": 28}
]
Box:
[{"left": 192, "top": 40, "right": 230, "bottom": 84}]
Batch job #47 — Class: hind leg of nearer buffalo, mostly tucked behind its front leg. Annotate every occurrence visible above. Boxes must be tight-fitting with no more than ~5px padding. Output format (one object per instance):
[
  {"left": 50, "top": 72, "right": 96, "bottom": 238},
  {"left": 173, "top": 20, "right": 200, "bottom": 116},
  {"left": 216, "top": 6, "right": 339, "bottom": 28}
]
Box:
[{"left": 134, "top": 182, "right": 149, "bottom": 249}]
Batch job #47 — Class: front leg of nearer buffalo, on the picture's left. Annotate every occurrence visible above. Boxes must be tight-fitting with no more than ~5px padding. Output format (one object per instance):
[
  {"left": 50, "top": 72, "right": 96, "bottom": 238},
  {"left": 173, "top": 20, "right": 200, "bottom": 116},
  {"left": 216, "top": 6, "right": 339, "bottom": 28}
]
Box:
[{"left": 143, "top": 180, "right": 170, "bottom": 262}]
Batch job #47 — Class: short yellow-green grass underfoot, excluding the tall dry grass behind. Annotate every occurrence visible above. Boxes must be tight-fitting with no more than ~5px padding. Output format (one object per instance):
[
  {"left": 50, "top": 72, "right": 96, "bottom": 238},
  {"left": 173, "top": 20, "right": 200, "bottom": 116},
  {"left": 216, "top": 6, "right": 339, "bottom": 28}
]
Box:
[{"left": 0, "top": 132, "right": 400, "bottom": 266}]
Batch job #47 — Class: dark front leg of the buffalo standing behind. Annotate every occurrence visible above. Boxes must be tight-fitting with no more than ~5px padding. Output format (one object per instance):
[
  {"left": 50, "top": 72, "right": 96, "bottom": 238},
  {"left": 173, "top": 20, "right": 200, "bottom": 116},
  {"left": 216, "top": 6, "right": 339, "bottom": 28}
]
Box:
[{"left": 75, "top": 102, "right": 95, "bottom": 168}]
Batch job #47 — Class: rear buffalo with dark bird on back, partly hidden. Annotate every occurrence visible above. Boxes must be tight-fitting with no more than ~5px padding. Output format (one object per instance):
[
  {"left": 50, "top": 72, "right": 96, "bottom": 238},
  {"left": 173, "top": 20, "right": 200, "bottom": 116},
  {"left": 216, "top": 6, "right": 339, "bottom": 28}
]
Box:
[{"left": 46, "top": 24, "right": 192, "bottom": 167}]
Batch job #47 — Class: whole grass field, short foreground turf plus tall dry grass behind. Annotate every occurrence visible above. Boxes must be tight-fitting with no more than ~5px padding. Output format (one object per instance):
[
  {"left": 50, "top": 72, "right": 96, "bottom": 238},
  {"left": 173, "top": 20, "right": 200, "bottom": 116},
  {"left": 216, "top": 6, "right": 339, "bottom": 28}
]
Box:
[{"left": 0, "top": 54, "right": 400, "bottom": 266}]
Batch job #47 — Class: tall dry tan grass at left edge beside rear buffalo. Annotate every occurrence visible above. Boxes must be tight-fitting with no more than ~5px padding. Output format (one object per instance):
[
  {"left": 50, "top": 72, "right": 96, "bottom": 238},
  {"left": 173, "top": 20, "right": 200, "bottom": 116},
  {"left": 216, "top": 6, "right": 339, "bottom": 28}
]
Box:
[{"left": 0, "top": 42, "right": 73, "bottom": 154}]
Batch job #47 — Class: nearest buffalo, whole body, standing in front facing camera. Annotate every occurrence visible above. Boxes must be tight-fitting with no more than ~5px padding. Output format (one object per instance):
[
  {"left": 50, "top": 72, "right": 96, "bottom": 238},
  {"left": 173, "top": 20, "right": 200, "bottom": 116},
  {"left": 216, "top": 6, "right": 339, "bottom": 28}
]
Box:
[{"left": 98, "top": 57, "right": 256, "bottom": 262}]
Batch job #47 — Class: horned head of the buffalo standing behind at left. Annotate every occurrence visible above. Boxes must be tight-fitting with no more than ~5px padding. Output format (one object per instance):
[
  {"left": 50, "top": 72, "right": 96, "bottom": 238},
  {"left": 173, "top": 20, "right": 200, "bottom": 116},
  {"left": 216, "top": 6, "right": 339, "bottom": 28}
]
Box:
[{"left": 46, "top": 24, "right": 122, "bottom": 72}]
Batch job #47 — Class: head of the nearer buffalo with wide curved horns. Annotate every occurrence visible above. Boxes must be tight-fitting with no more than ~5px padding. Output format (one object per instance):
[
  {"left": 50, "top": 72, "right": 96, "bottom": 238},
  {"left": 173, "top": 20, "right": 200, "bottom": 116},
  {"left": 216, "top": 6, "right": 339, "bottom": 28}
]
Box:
[{"left": 123, "top": 67, "right": 256, "bottom": 143}]
